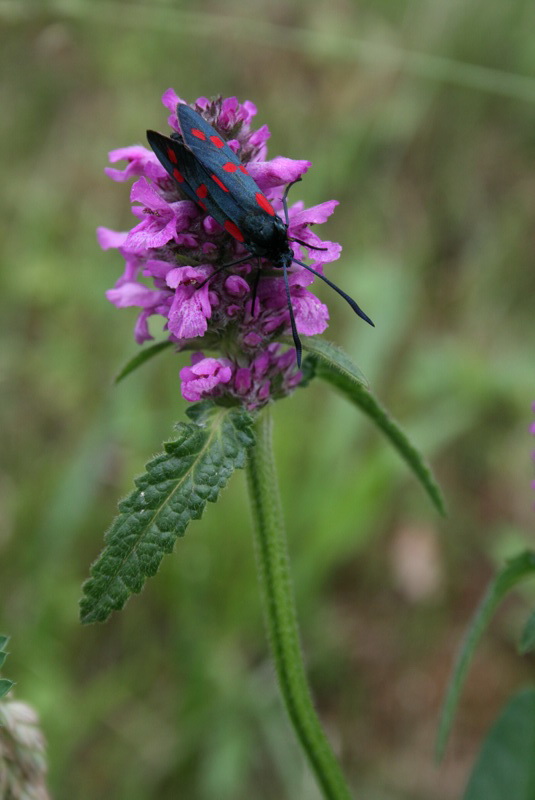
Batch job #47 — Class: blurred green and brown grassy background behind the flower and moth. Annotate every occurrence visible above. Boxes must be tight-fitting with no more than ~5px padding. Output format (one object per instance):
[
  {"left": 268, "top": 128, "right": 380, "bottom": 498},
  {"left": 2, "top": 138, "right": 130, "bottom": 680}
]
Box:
[{"left": 0, "top": 0, "right": 535, "bottom": 800}]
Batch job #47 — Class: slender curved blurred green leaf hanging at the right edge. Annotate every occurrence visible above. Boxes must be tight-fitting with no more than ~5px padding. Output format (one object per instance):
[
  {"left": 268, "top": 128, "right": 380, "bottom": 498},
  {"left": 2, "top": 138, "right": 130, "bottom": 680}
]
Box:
[{"left": 436, "top": 550, "right": 535, "bottom": 759}]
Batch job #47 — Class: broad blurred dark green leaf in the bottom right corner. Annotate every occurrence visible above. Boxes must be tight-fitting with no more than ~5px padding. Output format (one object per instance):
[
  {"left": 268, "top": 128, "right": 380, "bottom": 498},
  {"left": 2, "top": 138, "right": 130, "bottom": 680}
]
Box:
[{"left": 463, "top": 689, "right": 535, "bottom": 800}]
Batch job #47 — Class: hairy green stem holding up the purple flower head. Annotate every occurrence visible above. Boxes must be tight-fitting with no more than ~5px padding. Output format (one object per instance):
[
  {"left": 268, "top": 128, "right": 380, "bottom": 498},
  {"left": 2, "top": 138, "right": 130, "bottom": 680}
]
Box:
[{"left": 247, "top": 409, "right": 351, "bottom": 800}]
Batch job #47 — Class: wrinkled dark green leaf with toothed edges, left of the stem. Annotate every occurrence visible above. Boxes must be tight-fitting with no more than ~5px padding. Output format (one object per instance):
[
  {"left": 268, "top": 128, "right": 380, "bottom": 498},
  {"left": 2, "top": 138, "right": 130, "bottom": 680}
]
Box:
[{"left": 80, "top": 403, "right": 254, "bottom": 623}]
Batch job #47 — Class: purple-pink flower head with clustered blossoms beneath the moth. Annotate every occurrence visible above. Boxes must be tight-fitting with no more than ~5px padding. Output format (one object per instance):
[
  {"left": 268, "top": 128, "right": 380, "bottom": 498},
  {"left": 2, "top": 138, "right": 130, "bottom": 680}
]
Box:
[{"left": 98, "top": 89, "right": 341, "bottom": 410}]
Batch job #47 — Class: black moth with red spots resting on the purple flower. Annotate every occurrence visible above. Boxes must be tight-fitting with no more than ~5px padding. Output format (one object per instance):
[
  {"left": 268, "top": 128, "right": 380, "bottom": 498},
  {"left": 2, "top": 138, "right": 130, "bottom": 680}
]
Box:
[{"left": 147, "top": 103, "right": 373, "bottom": 366}]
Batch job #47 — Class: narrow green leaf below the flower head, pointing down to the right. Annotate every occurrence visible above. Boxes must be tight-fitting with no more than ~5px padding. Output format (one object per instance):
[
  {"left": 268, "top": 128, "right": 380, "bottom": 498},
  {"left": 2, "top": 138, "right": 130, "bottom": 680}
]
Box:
[{"left": 303, "top": 338, "right": 446, "bottom": 516}]
